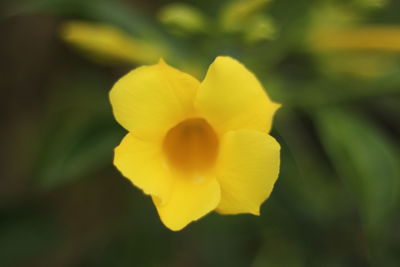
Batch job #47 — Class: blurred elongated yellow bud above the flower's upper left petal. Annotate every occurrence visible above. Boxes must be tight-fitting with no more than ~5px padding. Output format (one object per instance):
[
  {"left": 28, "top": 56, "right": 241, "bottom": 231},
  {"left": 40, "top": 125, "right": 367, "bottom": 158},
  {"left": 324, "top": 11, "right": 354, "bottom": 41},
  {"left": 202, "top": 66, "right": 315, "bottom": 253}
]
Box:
[{"left": 60, "top": 21, "right": 165, "bottom": 64}]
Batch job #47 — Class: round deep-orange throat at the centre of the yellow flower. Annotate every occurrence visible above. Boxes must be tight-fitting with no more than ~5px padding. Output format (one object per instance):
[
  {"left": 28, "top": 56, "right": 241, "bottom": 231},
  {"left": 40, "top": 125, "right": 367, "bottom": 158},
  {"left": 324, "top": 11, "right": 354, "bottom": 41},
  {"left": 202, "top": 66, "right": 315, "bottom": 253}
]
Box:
[{"left": 163, "top": 118, "right": 218, "bottom": 173}]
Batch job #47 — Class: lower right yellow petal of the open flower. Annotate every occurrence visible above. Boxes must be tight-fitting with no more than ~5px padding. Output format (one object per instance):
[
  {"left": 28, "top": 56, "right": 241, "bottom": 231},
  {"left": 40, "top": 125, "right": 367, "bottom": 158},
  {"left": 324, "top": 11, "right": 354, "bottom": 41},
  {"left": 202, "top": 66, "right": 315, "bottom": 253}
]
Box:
[{"left": 217, "top": 130, "right": 280, "bottom": 215}]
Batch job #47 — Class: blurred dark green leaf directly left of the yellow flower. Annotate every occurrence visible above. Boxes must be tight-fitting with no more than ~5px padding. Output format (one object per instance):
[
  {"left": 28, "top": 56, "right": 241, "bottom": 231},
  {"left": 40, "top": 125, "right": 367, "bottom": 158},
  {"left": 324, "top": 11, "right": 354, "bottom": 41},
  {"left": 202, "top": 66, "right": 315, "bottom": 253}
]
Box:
[{"left": 32, "top": 117, "right": 120, "bottom": 190}]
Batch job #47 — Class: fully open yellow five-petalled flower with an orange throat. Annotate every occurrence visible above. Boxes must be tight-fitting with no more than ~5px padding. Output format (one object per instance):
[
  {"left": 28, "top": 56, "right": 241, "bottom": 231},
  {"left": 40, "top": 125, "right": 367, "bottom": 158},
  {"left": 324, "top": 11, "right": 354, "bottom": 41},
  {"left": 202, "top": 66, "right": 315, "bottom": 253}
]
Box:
[{"left": 110, "top": 57, "right": 280, "bottom": 231}]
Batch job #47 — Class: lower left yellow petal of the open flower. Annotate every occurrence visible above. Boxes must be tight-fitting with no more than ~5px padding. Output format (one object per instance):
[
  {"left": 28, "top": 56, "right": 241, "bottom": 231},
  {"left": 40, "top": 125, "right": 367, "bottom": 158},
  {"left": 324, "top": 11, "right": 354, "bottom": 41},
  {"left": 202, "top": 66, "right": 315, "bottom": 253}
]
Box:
[{"left": 114, "top": 133, "right": 171, "bottom": 201}]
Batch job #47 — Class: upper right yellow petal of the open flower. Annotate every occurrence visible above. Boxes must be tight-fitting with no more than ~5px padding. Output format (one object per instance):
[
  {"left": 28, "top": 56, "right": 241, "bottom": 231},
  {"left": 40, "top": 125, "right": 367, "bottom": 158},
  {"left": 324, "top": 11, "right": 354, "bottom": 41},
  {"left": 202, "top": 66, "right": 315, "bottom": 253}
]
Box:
[{"left": 195, "top": 57, "right": 280, "bottom": 133}]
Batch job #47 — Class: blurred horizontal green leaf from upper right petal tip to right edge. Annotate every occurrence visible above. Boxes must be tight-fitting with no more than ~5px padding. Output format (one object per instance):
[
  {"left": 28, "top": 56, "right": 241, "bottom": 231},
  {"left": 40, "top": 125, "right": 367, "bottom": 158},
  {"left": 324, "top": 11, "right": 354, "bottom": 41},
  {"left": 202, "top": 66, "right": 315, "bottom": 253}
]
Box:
[{"left": 265, "top": 71, "right": 400, "bottom": 109}]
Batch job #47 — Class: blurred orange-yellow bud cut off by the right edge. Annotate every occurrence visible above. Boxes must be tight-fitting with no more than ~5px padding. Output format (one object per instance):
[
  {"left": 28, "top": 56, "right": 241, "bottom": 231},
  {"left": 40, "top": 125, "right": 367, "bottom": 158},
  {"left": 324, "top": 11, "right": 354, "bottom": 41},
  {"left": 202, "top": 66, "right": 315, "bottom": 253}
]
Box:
[{"left": 310, "top": 26, "right": 400, "bottom": 52}]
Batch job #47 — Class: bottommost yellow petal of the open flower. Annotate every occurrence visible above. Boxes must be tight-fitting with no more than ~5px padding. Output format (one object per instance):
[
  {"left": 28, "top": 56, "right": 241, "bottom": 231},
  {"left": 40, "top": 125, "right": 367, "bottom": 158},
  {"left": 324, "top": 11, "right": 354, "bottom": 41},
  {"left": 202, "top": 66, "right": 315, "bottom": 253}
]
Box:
[{"left": 153, "top": 177, "right": 220, "bottom": 231}]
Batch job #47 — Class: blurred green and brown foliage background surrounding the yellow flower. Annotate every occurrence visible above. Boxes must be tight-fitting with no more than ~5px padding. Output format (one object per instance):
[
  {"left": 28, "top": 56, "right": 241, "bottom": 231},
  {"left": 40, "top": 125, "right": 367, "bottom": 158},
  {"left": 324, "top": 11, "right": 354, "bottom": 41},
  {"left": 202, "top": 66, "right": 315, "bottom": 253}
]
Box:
[{"left": 0, "top": 0, "right": 400, "bottom": 267}]
